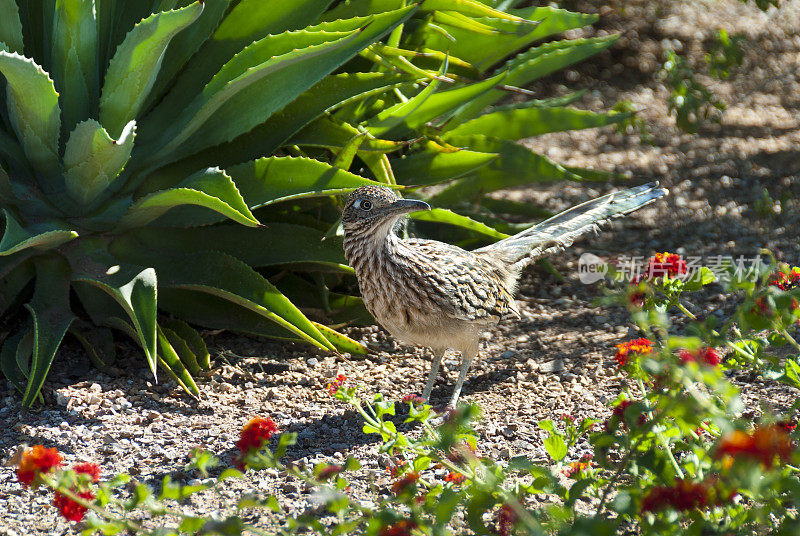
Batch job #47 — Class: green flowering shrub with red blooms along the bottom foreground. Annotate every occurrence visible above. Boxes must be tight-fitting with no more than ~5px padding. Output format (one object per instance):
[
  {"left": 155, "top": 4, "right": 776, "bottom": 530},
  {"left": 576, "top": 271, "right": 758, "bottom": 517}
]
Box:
[{"left": 10, "top": 253, "right": 800, "bottom": 536}]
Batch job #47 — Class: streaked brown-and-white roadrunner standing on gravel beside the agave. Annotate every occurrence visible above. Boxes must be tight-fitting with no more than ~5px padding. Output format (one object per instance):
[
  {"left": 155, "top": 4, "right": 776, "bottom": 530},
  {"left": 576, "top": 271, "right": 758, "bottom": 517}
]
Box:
[{"left": 342, "top": 182, "right": 669, "bottom": 408}]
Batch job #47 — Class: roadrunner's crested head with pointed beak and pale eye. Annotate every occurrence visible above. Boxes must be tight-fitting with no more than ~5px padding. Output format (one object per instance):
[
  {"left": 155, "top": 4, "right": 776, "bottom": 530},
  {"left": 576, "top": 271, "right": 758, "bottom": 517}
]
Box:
[{"left": 342, "top": 186, "right": 431, "bottom": 238}]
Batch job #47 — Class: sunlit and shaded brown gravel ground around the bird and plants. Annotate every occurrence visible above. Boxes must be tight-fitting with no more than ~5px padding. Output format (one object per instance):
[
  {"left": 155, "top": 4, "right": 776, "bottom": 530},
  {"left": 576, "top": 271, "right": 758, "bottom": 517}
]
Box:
[{"left": 0, "top": 0, "right": 800, "bottom": 536}]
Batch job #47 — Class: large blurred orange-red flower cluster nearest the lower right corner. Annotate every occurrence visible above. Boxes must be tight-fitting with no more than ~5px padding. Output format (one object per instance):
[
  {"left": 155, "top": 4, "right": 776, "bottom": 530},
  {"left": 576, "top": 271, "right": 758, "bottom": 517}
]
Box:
[{"left": 715, "top": 424, "right": 793, "bottom": 467}]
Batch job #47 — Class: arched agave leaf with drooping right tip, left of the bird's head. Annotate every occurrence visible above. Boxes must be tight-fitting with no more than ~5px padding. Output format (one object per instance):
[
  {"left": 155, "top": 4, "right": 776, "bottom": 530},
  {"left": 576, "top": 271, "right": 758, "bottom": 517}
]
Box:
[{"left": 118, "top": 168, "right": 258, "bottom": 230}]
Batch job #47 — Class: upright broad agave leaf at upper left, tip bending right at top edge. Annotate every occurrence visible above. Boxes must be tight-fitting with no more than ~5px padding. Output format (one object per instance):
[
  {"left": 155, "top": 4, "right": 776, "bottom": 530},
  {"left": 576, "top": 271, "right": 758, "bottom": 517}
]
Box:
[{"left": 100, "top": 1, "right": 203, "bottom": 138}]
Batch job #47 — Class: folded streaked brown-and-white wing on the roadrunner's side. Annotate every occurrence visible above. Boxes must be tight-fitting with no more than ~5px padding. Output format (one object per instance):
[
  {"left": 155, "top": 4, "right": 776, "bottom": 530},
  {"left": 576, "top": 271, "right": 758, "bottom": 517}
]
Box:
[{"left": 402, "top": 239, "right": 519, "bottom": 322}]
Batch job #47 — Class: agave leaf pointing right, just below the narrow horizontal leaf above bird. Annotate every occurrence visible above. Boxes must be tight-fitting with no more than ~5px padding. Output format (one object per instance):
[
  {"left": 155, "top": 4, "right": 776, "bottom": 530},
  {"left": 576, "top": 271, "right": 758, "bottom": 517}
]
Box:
[{"left": 431, "top": 135, "right": 580, "bottom": 206}]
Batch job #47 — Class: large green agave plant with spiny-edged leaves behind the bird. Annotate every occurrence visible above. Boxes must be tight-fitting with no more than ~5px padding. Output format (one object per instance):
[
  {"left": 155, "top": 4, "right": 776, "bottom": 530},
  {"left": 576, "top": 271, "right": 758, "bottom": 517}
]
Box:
[{"left": 0, "top": 0, "right": 624, "bottom": 405}]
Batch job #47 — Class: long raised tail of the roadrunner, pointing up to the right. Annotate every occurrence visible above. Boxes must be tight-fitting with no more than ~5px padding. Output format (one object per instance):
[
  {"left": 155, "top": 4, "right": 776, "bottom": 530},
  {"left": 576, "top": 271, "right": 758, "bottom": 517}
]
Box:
[{"left": 476, "top": 182, "right": 669, "bottom": 268}]
